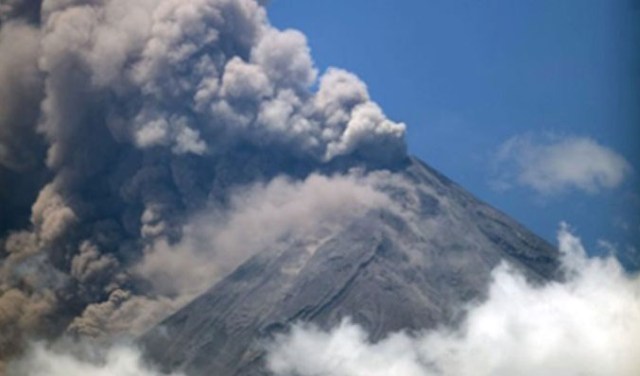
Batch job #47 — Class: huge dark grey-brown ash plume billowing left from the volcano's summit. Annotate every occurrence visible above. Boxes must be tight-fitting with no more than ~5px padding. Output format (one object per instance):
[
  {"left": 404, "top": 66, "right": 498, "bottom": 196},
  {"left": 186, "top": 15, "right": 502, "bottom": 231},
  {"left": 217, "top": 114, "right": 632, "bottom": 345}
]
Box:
[{"left": 0, "top": 0, "right": 405, "bottom": 368}]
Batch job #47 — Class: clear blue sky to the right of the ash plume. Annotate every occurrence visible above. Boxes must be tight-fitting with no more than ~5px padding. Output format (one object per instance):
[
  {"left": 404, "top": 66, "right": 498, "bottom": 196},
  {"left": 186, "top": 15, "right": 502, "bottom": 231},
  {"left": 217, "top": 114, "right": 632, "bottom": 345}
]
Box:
[{"left": 269, "top": 0, "right": 640, "bottom": 266}]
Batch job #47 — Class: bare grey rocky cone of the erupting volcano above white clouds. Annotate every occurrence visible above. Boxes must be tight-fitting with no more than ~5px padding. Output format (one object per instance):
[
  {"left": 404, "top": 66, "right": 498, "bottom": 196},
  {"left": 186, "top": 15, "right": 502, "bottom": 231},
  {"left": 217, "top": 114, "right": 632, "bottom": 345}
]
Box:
[{"left": 141, "top": 159, "right": 559, "bottom": 376}]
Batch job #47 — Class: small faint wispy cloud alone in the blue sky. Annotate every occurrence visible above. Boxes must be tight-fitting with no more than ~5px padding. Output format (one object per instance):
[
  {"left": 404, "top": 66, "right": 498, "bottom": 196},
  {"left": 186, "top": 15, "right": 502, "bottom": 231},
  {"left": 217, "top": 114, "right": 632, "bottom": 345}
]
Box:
[{"left": 497, "top": 135, "right": 632, "bottom": 195}]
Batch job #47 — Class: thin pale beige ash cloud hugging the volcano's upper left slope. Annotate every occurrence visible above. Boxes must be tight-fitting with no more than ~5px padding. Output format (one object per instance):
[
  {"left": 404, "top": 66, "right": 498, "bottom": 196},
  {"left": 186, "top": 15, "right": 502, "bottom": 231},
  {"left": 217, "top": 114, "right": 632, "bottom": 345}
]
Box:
[{"left": 135, "top": 174, "right": 390, "bottom": 296}]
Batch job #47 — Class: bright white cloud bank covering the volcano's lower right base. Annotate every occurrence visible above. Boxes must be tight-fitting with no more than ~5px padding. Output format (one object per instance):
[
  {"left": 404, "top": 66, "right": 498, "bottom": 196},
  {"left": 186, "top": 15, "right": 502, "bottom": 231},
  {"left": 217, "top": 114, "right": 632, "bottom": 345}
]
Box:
[{"left": 267, "top": 224, "right": 640, "bottom": 376}]
